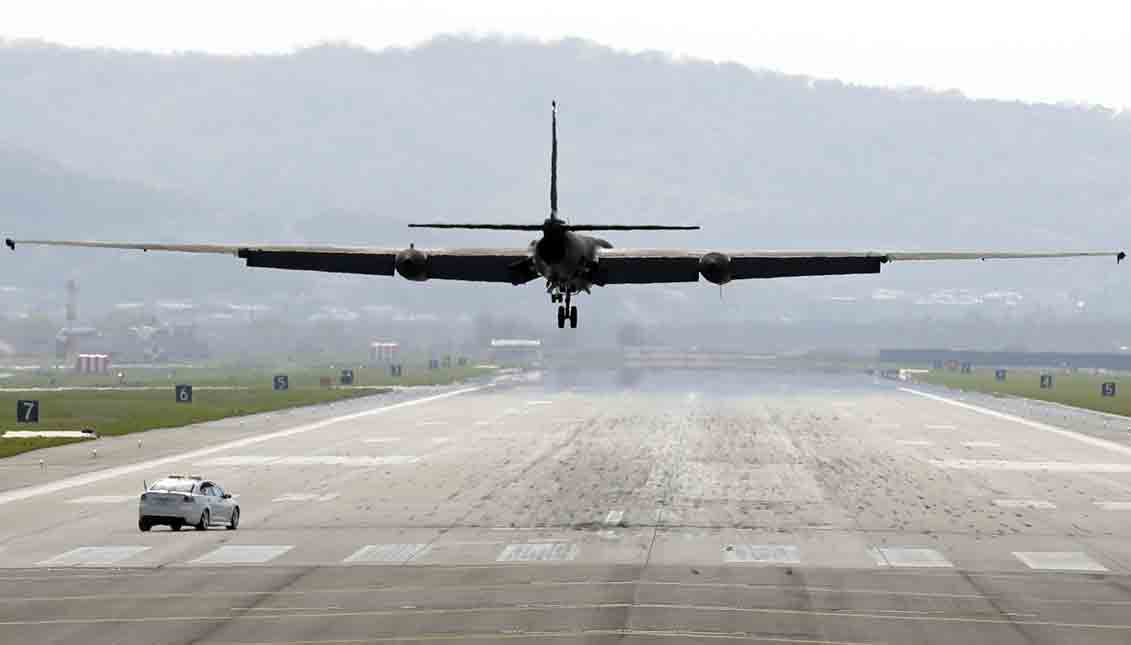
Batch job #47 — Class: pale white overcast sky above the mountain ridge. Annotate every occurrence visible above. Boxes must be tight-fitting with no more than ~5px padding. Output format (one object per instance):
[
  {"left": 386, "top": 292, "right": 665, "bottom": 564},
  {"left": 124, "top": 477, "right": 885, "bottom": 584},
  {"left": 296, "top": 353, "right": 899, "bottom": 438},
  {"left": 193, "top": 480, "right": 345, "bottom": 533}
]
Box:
[{"left": 8, "top": 0, "right": 1131, "bottom": 108}]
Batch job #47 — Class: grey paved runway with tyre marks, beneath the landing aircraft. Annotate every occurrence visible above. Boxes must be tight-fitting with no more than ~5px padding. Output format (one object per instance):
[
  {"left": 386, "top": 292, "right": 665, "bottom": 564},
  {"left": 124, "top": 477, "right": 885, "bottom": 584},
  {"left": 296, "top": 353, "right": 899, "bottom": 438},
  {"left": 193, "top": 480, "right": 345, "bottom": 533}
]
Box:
[{"left": 0, "top": 372, "right": 1131, "bottom": 645}]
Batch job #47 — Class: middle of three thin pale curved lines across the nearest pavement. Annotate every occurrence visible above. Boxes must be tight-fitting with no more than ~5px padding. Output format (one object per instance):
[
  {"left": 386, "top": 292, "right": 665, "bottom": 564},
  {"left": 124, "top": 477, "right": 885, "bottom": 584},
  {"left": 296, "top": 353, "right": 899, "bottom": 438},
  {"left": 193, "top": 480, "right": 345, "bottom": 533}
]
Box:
[{"left": 0, "top": 602, "right": 1131, "bottom": 629}]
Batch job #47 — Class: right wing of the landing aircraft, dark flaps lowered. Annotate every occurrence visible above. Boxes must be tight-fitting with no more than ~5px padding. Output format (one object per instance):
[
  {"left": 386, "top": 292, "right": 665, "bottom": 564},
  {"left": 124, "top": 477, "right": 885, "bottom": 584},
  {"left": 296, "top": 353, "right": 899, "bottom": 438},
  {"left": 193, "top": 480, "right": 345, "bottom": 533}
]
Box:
[{"left": 594, "top": 249, "right": 1125, "bottom": 285}]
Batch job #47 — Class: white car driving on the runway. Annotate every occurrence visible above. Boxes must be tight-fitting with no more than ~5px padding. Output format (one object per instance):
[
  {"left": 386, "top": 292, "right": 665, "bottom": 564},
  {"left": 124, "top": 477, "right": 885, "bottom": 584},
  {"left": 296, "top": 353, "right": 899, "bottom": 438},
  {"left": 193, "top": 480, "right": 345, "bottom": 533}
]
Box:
[{"left": 138, "top": 475, "right": 240, "bottom": 531}]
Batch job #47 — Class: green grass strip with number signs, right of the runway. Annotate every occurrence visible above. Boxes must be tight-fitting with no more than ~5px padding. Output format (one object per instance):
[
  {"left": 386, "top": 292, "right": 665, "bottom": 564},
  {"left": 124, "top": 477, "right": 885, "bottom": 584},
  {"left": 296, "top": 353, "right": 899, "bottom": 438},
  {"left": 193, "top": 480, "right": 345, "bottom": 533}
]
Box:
[{"left": 915, "top": 369, "right": 1131, "bottom": 416}]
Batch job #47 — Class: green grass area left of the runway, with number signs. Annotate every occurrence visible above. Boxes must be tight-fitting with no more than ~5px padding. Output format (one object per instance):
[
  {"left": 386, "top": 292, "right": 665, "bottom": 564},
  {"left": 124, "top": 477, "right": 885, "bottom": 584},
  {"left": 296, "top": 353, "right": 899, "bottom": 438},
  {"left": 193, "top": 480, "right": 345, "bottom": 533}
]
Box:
[{"left": 0, "top": 366, "right": 495, "bottom": 457}]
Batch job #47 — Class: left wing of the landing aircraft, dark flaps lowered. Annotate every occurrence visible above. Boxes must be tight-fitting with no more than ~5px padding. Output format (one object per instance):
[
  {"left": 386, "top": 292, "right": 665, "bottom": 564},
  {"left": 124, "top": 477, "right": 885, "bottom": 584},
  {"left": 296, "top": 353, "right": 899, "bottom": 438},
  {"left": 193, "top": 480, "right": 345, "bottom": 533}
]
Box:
[{"left": 5, "top": 239, "right": 537, "bottom": 284}]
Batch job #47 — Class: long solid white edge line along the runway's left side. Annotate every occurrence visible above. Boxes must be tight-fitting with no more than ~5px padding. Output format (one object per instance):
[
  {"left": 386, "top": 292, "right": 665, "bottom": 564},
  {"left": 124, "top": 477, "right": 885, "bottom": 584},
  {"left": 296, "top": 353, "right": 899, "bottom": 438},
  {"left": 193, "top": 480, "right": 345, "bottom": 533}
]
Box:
[{"left": 0, "top": 386, "right": 486, "bottom": 505}]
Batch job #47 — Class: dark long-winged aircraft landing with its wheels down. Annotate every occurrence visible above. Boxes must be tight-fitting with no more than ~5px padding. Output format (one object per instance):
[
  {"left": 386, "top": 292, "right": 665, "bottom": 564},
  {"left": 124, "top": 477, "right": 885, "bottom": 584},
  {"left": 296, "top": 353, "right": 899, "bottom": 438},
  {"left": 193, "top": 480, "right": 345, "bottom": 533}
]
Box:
[{"left": 5, "top": 102, "right": 1125, "bottom": 328}]
